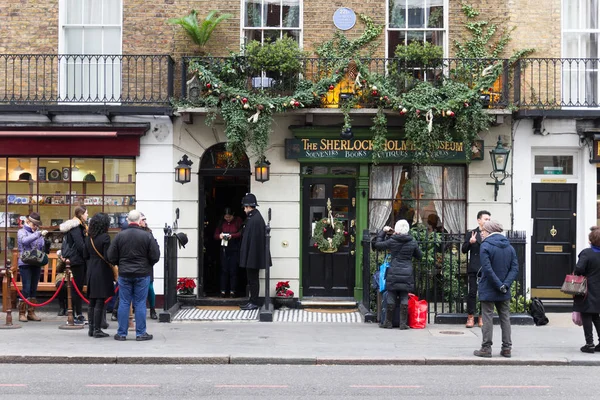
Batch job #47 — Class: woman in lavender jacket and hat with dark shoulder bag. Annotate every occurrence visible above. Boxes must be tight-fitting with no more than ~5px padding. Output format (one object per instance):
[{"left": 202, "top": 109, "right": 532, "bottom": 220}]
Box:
[{"left": 17, "top": 212, "right": 48, "bottom": 322}]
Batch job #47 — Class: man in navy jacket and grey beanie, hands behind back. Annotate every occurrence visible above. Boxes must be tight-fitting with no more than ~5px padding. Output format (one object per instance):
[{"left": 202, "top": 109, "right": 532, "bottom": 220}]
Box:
[{"left": 473, "top": 220, "right": 519, "bottom": 358}]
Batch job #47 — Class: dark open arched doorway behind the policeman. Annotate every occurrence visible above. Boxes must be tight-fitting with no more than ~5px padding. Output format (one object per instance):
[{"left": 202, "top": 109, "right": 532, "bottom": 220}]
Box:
[{"left": 198, "top": 143, "right": 251, "bottom": 300}]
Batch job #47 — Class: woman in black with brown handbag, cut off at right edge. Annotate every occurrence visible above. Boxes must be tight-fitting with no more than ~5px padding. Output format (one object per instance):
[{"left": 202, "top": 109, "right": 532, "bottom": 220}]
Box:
[{"left": 573, "top": 226, "right": 600, "bottom": 353}]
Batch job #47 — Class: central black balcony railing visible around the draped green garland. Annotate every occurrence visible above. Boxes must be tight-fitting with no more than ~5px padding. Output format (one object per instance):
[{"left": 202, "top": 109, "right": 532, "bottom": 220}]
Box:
[{"left": 181, "top": 57, "right": 509, "bottom": 108}]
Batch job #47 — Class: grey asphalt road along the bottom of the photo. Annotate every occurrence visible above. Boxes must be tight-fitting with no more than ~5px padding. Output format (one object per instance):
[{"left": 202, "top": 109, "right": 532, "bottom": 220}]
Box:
[{"left": 0, "top": 366, "right": 600, "bottom": 400}]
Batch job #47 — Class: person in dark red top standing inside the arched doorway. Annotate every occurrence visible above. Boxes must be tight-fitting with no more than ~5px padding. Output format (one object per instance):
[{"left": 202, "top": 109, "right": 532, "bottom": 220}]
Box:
[{"left": 213, "top": 207, "right": 242, "bottom": 298}]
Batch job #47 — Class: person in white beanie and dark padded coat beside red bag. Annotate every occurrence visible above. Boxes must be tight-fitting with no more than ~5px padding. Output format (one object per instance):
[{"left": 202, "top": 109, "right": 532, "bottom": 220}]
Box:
[{"left": 373, "top": 219, "right": 423, "bottom": 330}]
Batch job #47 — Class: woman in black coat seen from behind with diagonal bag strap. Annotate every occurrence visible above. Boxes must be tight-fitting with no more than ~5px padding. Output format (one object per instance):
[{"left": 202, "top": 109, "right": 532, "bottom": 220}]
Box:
[{"left": 83, "top": 213, "right": 114, "bottom": 338}]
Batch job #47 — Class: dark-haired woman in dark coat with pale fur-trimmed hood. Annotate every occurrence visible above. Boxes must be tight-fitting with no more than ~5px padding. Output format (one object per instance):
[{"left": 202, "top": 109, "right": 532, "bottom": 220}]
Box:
[{"left": 60, "top": 206, "right": 88, "bottom": 324}]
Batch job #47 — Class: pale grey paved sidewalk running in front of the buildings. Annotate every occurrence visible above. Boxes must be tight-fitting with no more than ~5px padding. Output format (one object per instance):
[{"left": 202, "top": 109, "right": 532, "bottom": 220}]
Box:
[{"left": 0, "top": 312, "right": 600, "bottom": 365}]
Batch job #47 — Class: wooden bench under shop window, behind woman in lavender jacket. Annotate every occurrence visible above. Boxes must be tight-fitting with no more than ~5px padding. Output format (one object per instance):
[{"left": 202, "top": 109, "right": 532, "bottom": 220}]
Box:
[{"left": 1, "top": 249, "right": 58, "bottom": 311}]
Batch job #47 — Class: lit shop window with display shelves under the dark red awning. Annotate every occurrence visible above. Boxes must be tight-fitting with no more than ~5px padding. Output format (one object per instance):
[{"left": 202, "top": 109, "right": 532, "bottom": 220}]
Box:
[{"left": 0, "top": 157, "right": 136, "bottom": 256}]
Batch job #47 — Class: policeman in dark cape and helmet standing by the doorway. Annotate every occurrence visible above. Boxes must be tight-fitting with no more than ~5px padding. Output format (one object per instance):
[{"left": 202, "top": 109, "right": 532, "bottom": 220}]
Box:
[{"left": 240, "top": 193, "right": 271, "bottom": 310}]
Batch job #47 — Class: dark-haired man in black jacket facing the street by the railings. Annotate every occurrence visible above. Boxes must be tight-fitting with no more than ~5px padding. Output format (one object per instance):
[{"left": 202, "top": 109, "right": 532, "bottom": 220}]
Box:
[{"left": 461, "top": 210, "right": 492, "bottom": 328}]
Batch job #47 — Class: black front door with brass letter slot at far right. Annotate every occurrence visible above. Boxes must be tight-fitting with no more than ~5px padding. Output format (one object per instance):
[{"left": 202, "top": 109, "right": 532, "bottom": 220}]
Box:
[{"left": 531, "top": 183, "right": 577, "bottom": 299}]
